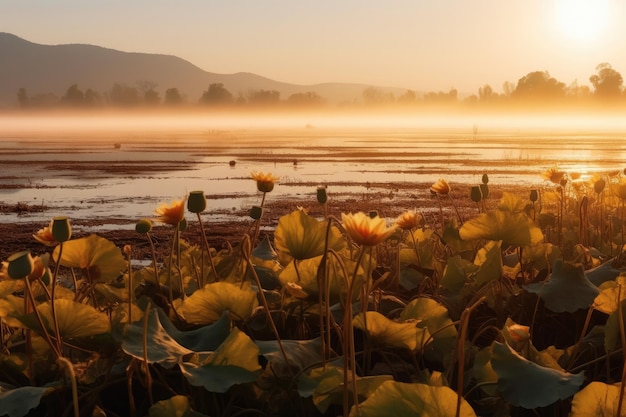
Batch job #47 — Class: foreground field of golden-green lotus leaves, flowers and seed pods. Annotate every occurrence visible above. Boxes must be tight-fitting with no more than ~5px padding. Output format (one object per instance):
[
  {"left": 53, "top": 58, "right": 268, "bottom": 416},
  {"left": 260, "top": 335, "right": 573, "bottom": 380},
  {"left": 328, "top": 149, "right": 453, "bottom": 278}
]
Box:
[{"left": 0, "top": 167, "right": 626, "bottom": 417}]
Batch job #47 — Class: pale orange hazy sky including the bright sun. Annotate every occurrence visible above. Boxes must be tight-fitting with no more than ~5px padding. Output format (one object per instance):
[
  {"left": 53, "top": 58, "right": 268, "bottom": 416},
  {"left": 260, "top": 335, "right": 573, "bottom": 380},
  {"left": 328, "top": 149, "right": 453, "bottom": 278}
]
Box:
[{"left": 0, "top": 0, "right": 626, "bottom": 93}]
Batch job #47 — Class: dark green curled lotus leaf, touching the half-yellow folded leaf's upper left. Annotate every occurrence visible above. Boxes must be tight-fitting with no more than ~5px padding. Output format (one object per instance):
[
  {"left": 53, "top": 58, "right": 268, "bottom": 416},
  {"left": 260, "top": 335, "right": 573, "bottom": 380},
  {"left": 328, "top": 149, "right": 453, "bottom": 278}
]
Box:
[{"left": 122, "top": 308, "right": 193, "bottom": 367}]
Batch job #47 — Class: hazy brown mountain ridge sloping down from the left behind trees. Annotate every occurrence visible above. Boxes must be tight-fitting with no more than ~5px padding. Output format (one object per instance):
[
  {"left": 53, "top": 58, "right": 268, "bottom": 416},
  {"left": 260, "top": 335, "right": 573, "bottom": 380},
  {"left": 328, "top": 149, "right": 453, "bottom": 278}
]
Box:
[{"left": 0, "top": 32, "right": 406, "bottom": 106}]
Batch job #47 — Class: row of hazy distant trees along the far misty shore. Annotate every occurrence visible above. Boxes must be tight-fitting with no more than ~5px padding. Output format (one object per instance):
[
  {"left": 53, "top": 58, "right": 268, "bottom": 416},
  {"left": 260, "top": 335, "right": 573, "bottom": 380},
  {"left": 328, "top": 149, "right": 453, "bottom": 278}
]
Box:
[{"left": 9, "top": 63, "right": 626, "bottom": 108}]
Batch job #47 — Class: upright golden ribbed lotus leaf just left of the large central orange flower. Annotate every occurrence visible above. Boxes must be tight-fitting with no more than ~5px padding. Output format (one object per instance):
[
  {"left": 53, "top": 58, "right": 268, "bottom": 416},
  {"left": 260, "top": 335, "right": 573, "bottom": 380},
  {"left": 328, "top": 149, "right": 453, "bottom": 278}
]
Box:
[{"left": 274, "top": 210, "right": 347, "bottom": 265}]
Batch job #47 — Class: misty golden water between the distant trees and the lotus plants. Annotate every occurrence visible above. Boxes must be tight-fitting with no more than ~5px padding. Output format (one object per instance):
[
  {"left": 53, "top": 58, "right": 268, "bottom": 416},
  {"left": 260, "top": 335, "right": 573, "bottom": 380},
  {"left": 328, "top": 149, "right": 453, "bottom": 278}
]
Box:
[{"left": 0, "top": 112, "right": 626, "bottom": 228}]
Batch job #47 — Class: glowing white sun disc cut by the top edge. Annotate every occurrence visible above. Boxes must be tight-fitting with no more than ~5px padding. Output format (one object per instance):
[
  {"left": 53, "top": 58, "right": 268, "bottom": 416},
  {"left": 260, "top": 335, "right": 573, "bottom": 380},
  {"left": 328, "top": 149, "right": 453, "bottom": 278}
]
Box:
[{"left": 555, "top": 0, "right": 610, "bottom": 43}]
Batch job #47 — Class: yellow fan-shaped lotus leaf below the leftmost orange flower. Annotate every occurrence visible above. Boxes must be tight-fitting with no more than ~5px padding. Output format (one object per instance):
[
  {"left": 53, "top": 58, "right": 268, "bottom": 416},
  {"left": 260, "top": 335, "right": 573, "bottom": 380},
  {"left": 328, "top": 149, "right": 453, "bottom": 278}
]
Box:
[{"left": 52, "top": 235, "right": 127, "bottom": 282}]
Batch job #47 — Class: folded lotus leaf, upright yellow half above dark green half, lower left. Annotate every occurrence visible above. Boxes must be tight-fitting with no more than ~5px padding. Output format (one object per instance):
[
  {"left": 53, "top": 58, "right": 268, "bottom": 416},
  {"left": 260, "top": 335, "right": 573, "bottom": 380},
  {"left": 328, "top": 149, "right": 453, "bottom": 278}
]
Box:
[{"left": 179, "top": 327, "right": 261, "bottom": 393}]
